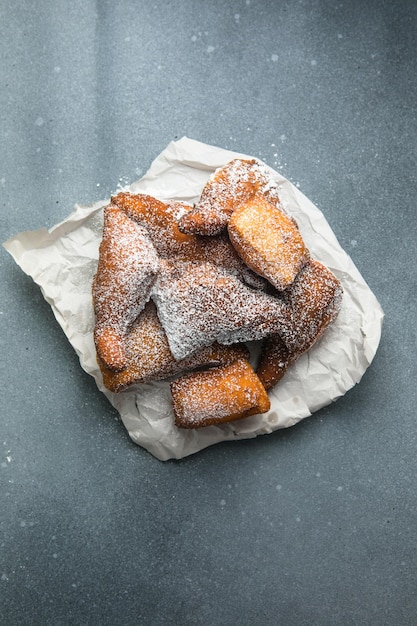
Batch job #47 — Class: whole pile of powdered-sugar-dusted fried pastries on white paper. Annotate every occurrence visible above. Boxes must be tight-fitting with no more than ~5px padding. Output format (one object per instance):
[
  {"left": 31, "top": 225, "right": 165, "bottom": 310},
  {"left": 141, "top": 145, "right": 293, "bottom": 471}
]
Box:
[{"left": 92, "top": 159, "right": 343, "bottom": 428}]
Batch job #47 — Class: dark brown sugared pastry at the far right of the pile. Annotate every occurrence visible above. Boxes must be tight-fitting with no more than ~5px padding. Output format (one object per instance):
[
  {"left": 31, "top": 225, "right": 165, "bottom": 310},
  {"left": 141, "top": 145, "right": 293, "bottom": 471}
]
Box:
[{"left": 256, "top": 259, "right": 343, "bottom": 389}]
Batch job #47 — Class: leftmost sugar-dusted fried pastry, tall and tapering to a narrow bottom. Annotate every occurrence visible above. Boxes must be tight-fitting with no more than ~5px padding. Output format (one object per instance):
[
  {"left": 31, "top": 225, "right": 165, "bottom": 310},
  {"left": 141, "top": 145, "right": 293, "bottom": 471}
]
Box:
[{"left": 92, "top": 205, "right": 159, "bottom": 372}]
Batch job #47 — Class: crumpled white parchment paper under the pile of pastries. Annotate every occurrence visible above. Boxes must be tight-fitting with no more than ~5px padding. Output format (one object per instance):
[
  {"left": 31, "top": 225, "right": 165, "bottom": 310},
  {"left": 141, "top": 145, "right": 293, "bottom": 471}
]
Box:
[{"left": 3, "top": 137, "right": 383, "bottom": 460}]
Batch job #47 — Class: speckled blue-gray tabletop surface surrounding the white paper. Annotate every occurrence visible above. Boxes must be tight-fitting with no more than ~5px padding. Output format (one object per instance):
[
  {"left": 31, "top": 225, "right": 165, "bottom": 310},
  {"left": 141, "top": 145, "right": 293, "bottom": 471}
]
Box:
[{"left": 0, "top": 0, "right": 417, "bottom": 626}]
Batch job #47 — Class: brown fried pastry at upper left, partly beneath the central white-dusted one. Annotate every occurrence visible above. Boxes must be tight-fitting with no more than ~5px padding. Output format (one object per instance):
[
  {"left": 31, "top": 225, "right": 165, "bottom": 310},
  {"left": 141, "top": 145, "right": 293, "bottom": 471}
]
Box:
[{"left": 112, "top": 192, "right": 265, "bottom": 289}]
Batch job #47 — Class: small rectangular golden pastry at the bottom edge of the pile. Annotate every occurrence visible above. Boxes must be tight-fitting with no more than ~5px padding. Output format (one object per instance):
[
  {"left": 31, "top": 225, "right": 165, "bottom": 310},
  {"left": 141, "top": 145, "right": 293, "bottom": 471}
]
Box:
[{"left": 171, "top": 359, "right": 271, "bottom": 428}]
